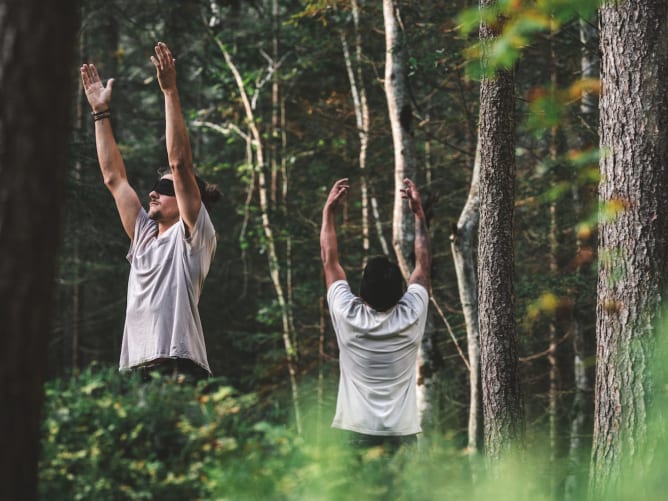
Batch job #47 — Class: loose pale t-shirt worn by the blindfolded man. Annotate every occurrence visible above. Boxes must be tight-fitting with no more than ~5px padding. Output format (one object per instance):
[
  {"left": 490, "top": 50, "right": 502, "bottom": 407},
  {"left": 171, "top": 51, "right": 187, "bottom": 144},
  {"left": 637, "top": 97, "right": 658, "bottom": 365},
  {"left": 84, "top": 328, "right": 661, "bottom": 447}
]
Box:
[{"left": 119, "top": 205, "right": 216, "bottom": 372}]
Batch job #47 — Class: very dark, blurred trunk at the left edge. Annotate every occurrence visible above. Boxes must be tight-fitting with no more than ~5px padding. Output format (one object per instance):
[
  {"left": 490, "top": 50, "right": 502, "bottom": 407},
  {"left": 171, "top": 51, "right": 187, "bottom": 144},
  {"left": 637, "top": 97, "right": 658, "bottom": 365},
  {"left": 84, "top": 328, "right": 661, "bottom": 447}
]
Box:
[{"left": 0, "top": 0, "right": 79, "bottom": 500}]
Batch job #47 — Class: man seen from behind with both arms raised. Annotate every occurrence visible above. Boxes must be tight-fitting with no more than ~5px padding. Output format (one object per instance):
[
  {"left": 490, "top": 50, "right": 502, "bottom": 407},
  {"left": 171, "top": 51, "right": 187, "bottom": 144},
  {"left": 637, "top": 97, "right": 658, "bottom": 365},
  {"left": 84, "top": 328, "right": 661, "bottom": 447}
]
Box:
[{"left": 320, "top": 178, "right": 431, "bottom": 451}]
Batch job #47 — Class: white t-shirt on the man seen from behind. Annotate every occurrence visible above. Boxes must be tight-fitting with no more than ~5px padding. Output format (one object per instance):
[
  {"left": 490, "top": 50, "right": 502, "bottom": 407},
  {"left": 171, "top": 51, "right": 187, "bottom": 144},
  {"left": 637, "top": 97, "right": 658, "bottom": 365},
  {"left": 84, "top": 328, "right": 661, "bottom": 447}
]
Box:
[{"left": 327, "top": 280, "right": 429, "bottom": 435}]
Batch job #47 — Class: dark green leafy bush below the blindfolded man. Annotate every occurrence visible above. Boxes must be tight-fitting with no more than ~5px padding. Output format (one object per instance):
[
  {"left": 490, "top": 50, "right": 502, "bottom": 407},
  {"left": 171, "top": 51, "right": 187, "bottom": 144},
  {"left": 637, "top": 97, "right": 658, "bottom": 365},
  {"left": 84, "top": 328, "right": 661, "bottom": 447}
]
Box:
[{"left": 40, "top": 369, "right": 254, "bottom": 500}]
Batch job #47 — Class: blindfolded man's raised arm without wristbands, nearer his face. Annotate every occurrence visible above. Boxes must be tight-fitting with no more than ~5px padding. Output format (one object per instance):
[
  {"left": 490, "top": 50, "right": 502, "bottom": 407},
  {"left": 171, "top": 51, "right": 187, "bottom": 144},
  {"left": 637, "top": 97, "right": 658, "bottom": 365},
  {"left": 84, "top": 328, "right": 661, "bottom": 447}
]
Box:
[{"left": 151, "top": 42, "right": 202, "bottom": 232}]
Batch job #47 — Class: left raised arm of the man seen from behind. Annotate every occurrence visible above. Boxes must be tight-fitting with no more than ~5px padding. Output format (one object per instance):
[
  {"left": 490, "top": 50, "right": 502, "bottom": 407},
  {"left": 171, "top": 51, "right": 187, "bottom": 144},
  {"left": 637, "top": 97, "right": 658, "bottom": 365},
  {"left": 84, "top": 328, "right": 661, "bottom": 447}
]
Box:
[{"left": 320, "top": 178, "right": 350, "bottom": 289}]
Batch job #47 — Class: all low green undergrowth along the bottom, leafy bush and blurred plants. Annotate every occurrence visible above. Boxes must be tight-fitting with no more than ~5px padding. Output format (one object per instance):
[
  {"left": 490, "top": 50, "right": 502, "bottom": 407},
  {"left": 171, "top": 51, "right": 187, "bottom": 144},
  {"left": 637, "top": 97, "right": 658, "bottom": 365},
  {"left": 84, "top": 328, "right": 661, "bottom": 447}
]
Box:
[{"left": 39, "top": 366, "right": 668, "bottom": 501}]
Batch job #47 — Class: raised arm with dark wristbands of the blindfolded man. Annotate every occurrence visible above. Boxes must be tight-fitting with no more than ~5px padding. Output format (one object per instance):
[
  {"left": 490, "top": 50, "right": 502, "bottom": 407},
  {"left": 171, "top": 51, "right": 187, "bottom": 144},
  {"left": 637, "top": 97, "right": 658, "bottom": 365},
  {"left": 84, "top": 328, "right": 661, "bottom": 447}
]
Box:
[{"left": 81, "top": 64, "right": 141, "bottom": 239}]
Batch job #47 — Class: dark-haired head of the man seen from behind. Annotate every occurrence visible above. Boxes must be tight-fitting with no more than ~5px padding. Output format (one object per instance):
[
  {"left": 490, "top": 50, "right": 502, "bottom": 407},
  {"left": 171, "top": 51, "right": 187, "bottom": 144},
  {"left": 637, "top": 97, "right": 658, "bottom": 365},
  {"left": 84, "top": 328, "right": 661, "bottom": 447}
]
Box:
[{"left": 360, "top": 256, "right": 404, "bottom": 311}]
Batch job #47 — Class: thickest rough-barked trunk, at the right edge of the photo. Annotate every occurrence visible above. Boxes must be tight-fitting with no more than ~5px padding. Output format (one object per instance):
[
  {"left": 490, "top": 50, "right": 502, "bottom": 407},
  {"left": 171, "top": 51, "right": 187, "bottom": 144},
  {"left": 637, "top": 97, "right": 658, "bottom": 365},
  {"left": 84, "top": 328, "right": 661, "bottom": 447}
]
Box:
[{"left": 589, "top": 0, "right": 668, "bottom": 496}]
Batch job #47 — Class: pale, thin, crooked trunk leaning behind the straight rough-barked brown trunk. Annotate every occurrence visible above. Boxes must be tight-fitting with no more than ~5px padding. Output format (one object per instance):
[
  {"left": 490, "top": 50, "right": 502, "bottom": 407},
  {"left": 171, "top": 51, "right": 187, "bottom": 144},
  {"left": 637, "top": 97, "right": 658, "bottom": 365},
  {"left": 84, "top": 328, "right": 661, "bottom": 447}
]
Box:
[{"left": 450, "top": 137, "right": 483, "bottom": 454}]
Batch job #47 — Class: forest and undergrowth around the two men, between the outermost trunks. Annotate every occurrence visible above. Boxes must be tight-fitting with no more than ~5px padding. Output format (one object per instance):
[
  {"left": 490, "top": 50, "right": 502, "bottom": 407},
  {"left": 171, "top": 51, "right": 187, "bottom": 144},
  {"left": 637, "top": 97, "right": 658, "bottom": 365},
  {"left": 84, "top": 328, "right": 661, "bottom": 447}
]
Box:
[{"left": 1, "top": 0, "right": 665, "bottom": 499}]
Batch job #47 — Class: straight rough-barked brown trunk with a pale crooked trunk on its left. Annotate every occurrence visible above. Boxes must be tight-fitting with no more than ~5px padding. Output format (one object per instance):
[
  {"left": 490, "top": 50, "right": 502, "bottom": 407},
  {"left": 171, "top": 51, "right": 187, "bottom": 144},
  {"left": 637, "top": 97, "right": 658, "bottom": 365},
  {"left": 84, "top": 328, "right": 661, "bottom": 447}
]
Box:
[{"left": 478, "top": 0, "right": 524, "bottom": 458}]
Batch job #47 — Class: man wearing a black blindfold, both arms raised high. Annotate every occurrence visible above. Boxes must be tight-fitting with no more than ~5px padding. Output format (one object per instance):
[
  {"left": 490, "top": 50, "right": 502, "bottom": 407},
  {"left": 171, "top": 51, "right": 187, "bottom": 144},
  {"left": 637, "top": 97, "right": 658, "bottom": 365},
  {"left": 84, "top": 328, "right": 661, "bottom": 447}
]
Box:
[{"left": 81, "top": 42, "right": 220, "bottom": 380}]
